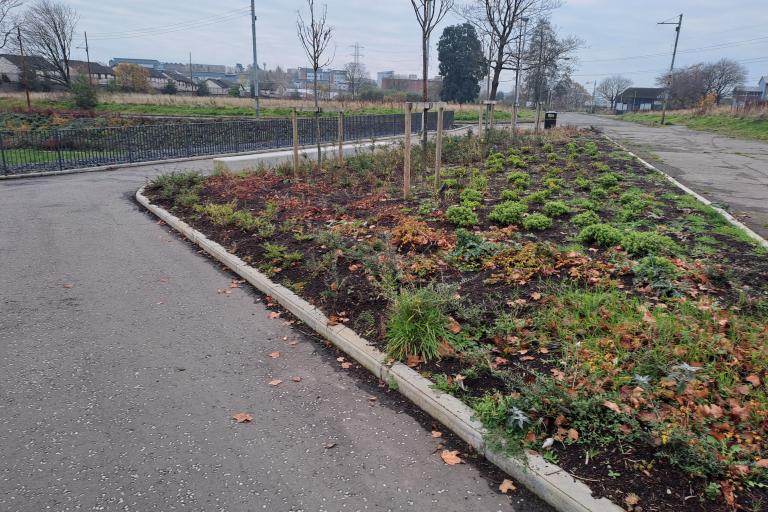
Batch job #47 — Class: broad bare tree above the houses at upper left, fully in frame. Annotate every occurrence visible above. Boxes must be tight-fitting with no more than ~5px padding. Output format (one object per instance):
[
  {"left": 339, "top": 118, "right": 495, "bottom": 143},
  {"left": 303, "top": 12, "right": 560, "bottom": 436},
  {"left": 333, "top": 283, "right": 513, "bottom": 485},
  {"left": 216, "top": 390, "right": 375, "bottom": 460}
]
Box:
[{"left": 21, "top": 0, "right": 80, "bottom": 87}]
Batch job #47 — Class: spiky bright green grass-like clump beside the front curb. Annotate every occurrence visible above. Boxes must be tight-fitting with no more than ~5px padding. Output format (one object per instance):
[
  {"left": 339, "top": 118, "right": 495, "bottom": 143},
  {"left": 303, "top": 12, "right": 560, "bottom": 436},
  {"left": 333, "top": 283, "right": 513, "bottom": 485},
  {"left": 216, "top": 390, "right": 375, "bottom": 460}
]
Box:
[{"left": 386, "top": 287, "right": 450, "bottom": 361}]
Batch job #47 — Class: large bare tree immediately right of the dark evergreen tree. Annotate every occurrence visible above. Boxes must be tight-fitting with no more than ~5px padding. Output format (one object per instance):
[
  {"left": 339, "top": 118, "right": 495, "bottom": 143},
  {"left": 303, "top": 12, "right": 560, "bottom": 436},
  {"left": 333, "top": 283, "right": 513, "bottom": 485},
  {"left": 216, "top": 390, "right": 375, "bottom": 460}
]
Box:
[{"left": 459, "top": 0, "right": 562, "bottom": 100}]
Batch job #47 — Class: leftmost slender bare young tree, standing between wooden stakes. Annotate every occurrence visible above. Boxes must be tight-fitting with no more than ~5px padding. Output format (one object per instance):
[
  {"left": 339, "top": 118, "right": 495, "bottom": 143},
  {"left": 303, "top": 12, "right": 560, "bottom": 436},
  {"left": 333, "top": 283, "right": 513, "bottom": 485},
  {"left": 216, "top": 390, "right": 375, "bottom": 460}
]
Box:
[{"left": 296, "top": 0, "right": 333, "bottom": 165}]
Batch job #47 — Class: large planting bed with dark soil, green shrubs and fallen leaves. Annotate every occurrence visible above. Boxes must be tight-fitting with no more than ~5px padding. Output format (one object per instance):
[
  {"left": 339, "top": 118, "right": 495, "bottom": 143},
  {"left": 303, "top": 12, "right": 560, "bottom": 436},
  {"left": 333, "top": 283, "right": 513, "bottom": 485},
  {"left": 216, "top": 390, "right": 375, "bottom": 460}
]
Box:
[{"left": 147, "top": 130, "right": 768, "bottom": 511}]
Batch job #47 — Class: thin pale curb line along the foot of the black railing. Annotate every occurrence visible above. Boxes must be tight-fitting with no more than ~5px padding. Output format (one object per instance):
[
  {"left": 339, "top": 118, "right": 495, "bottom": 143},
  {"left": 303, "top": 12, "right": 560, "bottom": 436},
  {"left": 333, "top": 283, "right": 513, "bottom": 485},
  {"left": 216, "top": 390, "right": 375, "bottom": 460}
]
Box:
[{"left": 0, "top": 126, "right": 467, "bottom": 182}]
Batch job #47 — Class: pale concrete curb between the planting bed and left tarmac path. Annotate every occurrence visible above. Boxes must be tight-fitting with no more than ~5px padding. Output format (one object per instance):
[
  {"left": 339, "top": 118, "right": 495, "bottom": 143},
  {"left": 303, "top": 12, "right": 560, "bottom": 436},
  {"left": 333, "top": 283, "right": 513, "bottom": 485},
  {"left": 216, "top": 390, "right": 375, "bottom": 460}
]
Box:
[{"left": 136, "top": 187, "right": 624, "bottom": 512}]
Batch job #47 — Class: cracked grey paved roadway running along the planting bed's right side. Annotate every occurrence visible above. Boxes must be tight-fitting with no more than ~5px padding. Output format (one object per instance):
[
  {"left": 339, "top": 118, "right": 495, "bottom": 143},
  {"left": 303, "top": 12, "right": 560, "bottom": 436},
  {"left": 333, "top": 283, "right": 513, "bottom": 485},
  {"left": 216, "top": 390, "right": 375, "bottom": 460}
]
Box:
[{"left": 558, "top": 113, "right": 768, "bottom": 238}]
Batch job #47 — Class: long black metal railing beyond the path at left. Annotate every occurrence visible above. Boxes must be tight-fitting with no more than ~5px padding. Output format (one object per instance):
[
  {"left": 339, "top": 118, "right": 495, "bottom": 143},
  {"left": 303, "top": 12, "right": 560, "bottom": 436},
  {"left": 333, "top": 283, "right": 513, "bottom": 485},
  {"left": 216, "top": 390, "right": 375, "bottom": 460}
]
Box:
[{"left": 0, "top": 111, "right": 453, "bottom": 174}]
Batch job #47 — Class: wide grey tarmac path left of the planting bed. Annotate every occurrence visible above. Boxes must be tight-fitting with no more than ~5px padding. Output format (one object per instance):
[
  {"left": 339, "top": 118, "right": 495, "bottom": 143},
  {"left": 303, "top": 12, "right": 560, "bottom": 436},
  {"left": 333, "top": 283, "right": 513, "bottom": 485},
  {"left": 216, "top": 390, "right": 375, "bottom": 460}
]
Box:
[{"left": 0, "top": 162, "right": 550, "bottom": 512}]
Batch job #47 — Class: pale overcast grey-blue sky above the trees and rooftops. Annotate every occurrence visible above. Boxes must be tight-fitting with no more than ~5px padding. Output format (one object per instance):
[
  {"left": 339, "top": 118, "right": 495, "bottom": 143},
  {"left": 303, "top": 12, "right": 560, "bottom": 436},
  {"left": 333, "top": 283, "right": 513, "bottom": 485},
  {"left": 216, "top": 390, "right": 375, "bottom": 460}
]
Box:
[{"left": 69, "top": 0, "right": 768, "bottom": 90}]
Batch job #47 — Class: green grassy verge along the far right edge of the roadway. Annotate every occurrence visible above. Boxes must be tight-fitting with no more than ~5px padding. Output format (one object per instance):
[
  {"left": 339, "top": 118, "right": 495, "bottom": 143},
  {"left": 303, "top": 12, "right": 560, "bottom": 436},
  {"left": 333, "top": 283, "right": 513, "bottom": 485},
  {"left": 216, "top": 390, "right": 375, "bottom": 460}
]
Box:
[{"left": 621, "top": 111, "right": 768, "bottom": 141}]
